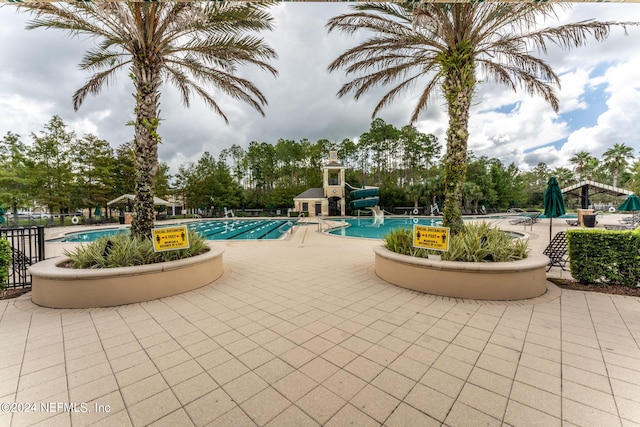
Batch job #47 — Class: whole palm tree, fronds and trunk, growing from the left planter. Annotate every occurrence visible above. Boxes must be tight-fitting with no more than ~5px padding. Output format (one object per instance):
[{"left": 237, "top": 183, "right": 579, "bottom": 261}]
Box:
[{"left": 19, "top": 2, "right": 277, "bottom": 238}]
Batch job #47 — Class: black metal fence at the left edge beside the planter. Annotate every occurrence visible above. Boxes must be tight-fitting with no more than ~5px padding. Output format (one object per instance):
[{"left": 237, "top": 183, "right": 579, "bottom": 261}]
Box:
[{"left": 0, "top": 226, "right": 44, "bottom": 288}]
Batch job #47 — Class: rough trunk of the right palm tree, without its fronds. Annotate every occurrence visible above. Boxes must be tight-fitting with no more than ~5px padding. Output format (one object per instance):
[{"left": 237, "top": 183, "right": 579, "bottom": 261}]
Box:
[{"left": 441, "top": 44, "right": 476, "bottom": 234}]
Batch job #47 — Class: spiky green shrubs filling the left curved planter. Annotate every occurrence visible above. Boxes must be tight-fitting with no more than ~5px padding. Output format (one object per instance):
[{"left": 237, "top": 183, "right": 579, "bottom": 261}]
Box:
[{"left": 65, "top": 230, "right": 209, "bottom": 268}]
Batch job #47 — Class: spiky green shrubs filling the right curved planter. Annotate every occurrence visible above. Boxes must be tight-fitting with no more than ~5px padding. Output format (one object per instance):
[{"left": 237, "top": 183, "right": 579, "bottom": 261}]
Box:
[{"left": 385, "top": 222, "right": 529, "bottom": 262}]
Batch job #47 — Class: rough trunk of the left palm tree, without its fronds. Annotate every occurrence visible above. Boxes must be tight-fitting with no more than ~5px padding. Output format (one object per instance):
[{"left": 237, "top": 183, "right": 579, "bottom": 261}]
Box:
[{"left": 131, "top": 64, "right": 160, "bottom": 239}]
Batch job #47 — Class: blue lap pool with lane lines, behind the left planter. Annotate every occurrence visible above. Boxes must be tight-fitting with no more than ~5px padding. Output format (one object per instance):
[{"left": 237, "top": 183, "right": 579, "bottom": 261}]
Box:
[{"left": 47, "top": 219, "right": 296, "bottom": 243}]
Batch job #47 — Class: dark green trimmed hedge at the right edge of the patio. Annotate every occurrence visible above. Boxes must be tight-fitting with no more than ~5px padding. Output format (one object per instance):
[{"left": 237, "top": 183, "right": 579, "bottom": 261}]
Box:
[{"left": 567, "top": 228, "right": 640, "bottom": 287}]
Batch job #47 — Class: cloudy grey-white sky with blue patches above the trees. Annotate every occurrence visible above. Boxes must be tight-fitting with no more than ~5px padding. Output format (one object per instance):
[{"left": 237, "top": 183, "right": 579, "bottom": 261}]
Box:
[{"left": 0, "top": 2, "right": 640, "bottom": 177}]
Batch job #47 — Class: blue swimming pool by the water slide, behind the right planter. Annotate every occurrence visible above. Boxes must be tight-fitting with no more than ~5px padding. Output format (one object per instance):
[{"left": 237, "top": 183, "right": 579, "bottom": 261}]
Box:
[{"left": 328, "top": 216, "right": 524, "bottom": 239}]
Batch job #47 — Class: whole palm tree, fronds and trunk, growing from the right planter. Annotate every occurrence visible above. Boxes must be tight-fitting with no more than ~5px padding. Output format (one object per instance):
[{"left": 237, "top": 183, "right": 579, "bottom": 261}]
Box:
[{"left": 327, "top": 2, "right": 637, "bottom": 233}]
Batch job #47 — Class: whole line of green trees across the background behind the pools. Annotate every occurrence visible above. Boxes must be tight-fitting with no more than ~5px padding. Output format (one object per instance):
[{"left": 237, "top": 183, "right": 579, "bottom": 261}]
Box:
[{"left": 0, "top": 116, "right": 640, "bottom": 221}]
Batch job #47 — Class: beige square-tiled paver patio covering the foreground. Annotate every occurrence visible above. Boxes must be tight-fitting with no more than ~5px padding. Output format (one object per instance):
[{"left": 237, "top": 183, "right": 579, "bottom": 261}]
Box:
[{"left": 0, "top": 222, "right": 640, "bottom": 427}]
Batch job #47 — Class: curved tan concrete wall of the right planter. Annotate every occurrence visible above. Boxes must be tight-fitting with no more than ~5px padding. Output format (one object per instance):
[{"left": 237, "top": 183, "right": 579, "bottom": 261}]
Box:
[{"left": 373, "top": 247, "right": 549, "bottom": 301}]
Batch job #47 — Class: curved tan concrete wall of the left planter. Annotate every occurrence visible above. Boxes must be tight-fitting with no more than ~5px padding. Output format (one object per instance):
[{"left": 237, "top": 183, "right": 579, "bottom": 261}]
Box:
[{"left": 29, "top": 247, "right": 224, "bottom": 308}]
